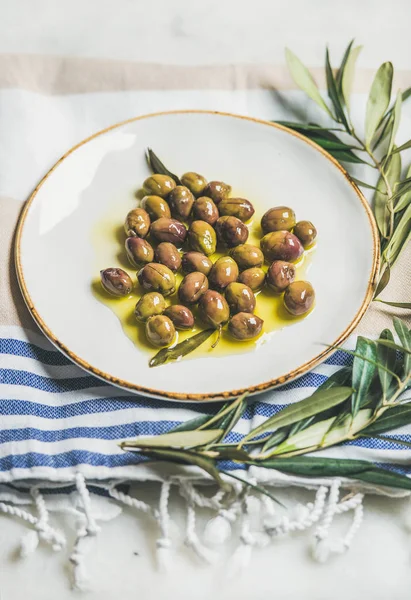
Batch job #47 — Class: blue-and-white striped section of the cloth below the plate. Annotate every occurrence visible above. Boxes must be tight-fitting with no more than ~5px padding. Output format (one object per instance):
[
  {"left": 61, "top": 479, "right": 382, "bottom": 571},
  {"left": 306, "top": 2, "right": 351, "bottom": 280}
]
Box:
[{"left": 0, "top": 328, "right": 411, "bottom": 481}]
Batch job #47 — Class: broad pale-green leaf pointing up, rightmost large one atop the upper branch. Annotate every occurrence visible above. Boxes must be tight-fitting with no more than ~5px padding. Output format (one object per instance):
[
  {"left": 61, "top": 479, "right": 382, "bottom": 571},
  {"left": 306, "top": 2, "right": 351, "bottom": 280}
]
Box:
[{"left": 365, "top": 62, "right": 394, "bottom": 146}]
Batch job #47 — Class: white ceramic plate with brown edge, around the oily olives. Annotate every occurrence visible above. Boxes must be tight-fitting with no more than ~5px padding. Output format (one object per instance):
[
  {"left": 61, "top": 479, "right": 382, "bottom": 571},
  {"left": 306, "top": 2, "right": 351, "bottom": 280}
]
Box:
[{"left": 16, "top": 111, "right": 384, "bottom": 400}]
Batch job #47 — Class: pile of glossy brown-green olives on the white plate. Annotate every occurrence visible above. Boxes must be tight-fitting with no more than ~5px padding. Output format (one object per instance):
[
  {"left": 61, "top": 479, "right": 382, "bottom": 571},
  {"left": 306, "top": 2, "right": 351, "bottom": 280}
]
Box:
[{"left": 100, "top": 172, "right": 317, "bottom": 347}]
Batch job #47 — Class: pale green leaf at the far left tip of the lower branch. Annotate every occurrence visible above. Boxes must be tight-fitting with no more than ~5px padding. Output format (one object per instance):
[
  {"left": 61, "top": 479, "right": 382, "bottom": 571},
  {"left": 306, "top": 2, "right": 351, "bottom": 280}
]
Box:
[{"left": 120, "top": 429, "right": 222, "bottom": 450}]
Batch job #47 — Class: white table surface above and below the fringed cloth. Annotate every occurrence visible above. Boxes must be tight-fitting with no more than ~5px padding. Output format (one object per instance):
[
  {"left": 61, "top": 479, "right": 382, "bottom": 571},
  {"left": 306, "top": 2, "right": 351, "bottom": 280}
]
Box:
[{"left": 0, "top": 0, "right": 411, "bottom": 600}]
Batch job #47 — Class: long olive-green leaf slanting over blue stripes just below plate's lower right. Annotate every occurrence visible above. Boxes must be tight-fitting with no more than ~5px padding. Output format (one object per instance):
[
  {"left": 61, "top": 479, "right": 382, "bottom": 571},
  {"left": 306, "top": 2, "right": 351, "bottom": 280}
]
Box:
[{"left": 241, "top": 387, "right": 352, "bottom": 445}]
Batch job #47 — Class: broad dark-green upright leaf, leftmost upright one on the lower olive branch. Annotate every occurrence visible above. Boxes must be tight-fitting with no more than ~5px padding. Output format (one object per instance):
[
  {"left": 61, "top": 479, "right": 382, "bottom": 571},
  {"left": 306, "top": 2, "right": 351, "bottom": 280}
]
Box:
[{"left": 351, "top": 336, "right": 377, "bottom": 417}]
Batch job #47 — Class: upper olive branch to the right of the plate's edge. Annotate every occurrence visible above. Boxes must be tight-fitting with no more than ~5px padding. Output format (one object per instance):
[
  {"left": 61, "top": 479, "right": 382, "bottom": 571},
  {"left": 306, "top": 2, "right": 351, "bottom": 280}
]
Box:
[{"left": 277, "top": 40, "right": 411, "bottom": 308}]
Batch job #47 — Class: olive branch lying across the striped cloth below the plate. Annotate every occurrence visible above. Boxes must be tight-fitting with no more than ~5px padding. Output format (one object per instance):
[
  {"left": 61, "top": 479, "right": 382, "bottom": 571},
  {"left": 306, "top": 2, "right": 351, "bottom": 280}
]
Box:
[{"left": 120, "top": 318, "right": 411, "bottom": 497}]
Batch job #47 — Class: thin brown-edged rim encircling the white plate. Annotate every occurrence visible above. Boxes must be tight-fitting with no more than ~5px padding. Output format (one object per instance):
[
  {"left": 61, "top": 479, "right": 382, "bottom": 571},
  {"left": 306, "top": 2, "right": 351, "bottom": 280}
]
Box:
[{"left": 14, "top": 109, "right": 380, "bottom": 402}]
